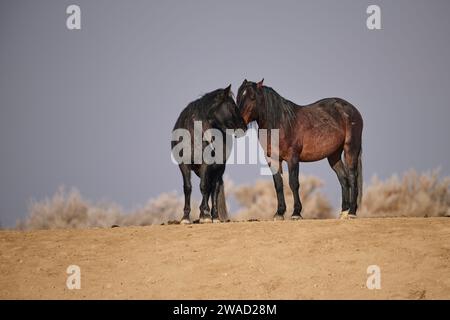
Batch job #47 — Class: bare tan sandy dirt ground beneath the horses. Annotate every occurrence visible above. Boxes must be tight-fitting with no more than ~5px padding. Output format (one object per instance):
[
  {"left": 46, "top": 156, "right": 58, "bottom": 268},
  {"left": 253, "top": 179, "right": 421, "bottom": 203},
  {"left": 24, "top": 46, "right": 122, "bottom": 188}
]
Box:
[{"left": 0, "top": 218, "right": 450, "bottom": 299}]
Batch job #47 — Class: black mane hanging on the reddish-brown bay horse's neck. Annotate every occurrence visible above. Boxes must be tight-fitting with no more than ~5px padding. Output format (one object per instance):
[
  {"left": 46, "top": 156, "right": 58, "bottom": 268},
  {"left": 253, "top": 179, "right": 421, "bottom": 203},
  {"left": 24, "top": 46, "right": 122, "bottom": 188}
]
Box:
[{"left": 258, "top": 86, "right": 298, "bottom": 129}]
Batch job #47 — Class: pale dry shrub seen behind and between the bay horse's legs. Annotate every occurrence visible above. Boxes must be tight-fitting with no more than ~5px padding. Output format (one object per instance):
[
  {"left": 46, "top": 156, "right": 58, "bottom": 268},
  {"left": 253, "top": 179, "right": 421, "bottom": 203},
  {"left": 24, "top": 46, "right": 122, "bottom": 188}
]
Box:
[{"left": 229, "top": 175, "right": 334, "bottom": 220}]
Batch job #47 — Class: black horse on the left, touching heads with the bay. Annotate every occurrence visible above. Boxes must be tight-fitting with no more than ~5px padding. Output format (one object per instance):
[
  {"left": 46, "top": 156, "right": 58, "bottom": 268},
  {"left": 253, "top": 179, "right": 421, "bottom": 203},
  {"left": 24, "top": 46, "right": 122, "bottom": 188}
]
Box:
[{"left": 172, "top": 85, "right": 247, "bottom": 224}]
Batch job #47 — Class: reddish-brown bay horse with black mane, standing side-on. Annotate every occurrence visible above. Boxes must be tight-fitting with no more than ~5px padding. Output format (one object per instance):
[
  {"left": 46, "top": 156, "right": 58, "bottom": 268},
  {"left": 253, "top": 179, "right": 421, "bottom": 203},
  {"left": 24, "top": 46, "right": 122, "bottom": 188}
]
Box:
[{"left": 237, "top": 79, "right": 363, "bottom": 220}]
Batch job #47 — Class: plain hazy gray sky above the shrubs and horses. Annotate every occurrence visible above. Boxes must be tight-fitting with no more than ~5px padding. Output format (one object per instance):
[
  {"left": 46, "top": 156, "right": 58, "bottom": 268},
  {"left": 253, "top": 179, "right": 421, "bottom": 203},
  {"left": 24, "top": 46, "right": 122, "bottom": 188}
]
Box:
[{"left": 0, "top": 0, "right": 450, "bottom": 226}]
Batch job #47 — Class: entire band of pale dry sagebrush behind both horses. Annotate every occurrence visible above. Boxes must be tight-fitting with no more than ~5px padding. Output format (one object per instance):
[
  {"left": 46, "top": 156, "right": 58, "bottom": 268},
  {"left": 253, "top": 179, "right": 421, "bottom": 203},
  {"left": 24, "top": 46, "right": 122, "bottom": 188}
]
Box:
[{"left": 17, "top": 171, "right": 450, "bottom": 230}]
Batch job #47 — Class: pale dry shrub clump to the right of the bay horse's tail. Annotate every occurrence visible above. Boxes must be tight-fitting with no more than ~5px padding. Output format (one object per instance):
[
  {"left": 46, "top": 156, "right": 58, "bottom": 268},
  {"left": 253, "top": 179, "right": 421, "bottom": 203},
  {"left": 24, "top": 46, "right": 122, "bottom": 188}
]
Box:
[{"left": 359, "top": 170, "right": 450, "bottom": 217}]
